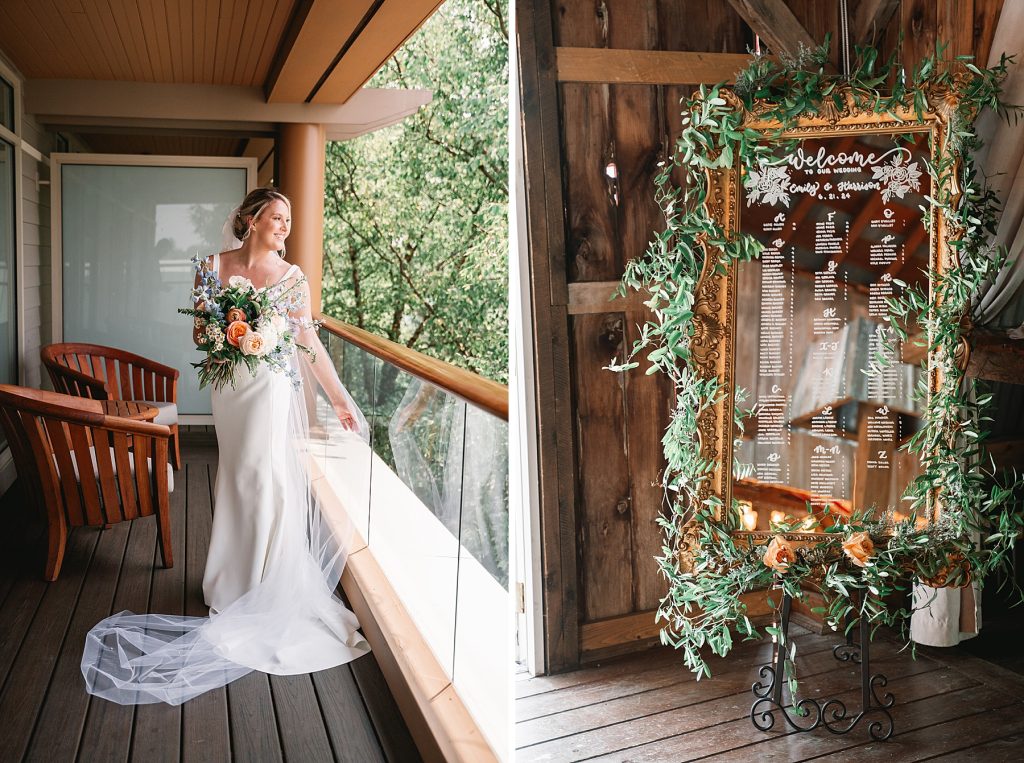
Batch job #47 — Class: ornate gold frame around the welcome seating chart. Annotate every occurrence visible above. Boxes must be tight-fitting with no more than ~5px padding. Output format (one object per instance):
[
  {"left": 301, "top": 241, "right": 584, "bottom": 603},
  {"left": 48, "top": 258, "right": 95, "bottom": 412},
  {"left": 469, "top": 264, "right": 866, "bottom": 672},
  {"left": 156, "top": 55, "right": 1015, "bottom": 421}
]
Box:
[{"left": 683, "top": 88, "right": 959, "bottom": 540}]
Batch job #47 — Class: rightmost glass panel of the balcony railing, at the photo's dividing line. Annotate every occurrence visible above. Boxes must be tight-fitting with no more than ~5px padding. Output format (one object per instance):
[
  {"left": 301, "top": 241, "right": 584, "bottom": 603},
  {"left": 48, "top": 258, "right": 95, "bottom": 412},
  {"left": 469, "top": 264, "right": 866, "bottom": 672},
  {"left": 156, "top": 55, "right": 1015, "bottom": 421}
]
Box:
[{"left": 453, "top": 406, "right": 511, "bottom": 750}]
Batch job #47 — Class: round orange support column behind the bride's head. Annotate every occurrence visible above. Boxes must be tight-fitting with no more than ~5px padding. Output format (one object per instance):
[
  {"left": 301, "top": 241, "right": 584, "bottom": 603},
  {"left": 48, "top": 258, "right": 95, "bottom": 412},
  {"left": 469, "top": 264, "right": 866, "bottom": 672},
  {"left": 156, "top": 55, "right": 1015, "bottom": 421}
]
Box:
[{"left": 278, "top": 124, "right": 327, "bottom": 312}]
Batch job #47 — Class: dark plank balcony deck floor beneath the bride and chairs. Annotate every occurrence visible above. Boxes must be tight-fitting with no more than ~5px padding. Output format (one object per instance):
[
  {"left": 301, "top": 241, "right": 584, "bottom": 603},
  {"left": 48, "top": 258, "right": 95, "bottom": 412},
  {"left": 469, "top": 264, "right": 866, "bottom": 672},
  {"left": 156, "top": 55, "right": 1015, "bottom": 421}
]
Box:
[{"left": 0, "top": 427, "right": 419, "bottom": 763}]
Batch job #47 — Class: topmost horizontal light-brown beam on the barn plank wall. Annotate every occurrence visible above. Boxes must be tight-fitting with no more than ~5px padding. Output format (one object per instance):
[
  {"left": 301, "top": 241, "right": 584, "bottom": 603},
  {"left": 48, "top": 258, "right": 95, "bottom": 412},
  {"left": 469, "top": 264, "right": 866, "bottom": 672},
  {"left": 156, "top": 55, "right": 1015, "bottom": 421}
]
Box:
[{"left": 555, "top": 47, "right": 751, "bottom": 85}]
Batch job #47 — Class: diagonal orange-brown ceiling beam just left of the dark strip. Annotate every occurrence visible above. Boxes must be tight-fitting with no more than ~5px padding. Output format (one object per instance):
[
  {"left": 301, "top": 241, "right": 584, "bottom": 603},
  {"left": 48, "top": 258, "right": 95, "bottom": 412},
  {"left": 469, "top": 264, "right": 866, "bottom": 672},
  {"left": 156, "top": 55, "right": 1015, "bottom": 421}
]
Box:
[{"left": 263, "top": 0, "right": 381, "bottom": 103}]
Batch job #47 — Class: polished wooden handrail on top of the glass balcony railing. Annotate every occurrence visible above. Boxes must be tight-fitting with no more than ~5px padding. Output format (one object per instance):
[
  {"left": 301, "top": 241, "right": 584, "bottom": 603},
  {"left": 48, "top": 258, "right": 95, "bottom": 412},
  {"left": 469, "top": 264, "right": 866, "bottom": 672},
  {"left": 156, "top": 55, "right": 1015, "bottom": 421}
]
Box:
[{"left": 316, "top": 314, "right": 509, "bottom": 421}]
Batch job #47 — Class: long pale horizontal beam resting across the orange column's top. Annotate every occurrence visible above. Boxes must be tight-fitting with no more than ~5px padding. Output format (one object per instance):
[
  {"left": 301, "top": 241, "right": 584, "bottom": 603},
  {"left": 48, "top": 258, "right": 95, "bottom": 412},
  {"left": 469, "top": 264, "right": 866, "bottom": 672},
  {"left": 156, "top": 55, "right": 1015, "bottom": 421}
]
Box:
[{"left": 25, "top": 80, "right": 432, "bottom": 140}]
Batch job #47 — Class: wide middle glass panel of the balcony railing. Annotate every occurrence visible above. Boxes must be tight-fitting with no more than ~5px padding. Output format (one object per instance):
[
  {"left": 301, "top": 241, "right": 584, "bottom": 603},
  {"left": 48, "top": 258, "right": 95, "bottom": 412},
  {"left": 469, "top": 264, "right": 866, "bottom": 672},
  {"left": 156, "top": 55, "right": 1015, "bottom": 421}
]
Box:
[{"left": 370, "top": 364, "right": 466, "bottom": 676}]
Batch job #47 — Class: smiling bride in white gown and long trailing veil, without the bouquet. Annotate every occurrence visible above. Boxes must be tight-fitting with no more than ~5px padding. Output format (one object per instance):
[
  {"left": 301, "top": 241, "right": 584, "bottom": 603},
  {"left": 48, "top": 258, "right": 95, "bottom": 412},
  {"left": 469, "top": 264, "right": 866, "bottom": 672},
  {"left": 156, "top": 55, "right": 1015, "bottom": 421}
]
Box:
[{"left": 82, "top": 188, "right": 370, "bottom": 705}]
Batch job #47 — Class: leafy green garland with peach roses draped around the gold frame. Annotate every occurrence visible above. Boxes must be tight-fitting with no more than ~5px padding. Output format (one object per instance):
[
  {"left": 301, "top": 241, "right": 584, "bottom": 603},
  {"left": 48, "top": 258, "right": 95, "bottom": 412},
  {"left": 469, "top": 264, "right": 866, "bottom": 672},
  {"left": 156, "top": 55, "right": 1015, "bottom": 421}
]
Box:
[{"left": 609, "top": 40, "right": 1024, "bottom": 692}]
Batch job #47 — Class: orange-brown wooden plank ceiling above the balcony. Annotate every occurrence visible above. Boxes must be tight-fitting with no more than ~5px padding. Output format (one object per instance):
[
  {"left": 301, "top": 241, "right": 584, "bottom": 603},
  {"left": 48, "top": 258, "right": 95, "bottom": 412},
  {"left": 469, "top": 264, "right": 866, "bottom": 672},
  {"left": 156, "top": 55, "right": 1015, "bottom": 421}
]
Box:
[{"left": 0, "top": 0, "right": 442, "bottom": 155}]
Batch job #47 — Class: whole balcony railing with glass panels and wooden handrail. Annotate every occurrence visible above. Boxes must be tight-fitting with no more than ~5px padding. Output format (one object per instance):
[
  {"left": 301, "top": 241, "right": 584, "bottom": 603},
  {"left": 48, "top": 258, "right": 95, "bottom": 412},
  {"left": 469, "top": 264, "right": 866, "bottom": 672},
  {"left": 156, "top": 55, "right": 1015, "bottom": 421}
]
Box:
[{"left": 314, "top": 316, "right": 511, "bottom": 757}]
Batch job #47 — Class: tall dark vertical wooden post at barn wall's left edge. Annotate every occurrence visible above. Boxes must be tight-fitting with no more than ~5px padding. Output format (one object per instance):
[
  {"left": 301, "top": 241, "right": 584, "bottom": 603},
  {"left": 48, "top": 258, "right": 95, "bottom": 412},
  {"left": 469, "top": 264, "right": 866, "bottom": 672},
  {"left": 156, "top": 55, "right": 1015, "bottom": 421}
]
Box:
[{"left": 515, "top": 0, "right": 580, "bottom": 673}]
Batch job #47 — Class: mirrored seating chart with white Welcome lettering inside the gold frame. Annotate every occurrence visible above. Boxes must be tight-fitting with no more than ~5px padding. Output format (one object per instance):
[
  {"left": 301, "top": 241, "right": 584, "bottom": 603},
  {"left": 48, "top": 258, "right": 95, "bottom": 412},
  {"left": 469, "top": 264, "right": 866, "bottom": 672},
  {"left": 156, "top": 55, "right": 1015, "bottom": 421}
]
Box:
[{"left": 733, "top": 132, "right": 931, "bottom": 532}]
